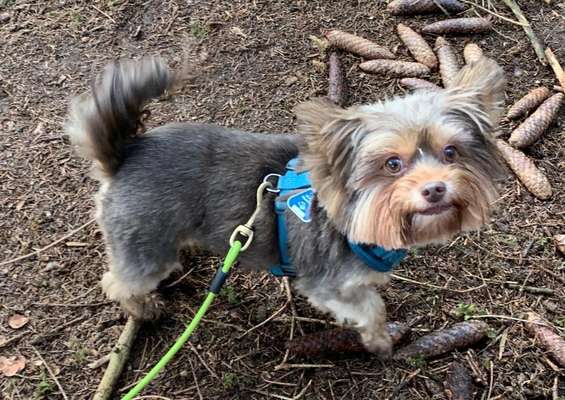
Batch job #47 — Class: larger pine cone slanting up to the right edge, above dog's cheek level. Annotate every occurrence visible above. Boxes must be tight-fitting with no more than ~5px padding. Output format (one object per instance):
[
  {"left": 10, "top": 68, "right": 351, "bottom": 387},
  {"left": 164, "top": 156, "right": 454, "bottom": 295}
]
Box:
[{"left": 508, "top": 93, "right": 565, "bottom": 148}]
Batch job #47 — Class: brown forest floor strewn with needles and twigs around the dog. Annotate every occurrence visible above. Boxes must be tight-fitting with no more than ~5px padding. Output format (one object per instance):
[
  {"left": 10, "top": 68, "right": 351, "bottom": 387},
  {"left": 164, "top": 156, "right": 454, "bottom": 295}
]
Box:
[{"left": 0, "top": 0, "right": 565, "bottom": 400}]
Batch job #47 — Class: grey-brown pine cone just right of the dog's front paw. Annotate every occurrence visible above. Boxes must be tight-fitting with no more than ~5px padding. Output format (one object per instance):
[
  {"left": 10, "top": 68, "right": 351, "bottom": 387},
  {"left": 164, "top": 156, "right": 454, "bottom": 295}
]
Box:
[{"left": 393, "top": 321, "right": 488, "bottom": 361}]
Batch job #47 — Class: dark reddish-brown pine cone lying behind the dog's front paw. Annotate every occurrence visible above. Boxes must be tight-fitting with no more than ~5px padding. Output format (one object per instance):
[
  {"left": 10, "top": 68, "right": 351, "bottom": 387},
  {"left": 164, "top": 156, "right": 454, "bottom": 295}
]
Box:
[{"left": 288, "top": 322, "right": 410, "bottom": 357}]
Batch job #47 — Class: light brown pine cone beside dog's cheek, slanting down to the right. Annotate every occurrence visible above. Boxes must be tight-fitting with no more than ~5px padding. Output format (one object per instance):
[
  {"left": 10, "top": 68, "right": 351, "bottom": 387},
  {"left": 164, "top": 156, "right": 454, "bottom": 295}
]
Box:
[{"left": 496, "top": 139, "right": 553, "bottom": 200}]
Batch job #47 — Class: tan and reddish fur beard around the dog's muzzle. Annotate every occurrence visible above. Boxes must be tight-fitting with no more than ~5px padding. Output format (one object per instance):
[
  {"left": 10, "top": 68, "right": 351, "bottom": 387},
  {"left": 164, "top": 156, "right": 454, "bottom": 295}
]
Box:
[{"left": 347, "top": 168, "right": 497, "bottom": 249}]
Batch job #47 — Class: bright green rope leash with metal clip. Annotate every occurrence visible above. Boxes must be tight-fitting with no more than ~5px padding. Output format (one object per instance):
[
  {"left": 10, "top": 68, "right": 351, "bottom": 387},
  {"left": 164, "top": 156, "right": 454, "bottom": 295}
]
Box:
[{"left": 122, "top": 182, "right": 272, "bottom": 400}]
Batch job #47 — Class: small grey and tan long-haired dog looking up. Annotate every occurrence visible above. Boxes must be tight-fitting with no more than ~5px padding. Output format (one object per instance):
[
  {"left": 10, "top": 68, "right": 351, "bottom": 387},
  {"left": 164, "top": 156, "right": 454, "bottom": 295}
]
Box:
[{"left": 67, "top": 58, "right": 505, "bottom": 354}]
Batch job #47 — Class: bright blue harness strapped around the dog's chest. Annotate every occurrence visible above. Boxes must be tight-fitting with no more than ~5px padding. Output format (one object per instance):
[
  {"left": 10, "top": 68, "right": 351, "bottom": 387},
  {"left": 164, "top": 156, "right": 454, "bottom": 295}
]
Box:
[{"left": 270, "top": 158, "right": 406, "bottom": 277}]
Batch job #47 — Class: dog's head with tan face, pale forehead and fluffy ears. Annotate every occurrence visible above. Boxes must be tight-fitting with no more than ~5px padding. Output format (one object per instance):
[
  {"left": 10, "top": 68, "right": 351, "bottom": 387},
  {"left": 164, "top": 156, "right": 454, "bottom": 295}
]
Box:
[{"left": 296, "top": 58, "right": 504, "bottom": 248}]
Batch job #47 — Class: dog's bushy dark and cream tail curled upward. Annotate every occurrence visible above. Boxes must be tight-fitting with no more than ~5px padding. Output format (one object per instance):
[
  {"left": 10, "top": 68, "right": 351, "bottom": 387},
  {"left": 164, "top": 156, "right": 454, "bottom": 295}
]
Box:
[{"left": 65, "top": 57, "right": 177, "bottom": 177}]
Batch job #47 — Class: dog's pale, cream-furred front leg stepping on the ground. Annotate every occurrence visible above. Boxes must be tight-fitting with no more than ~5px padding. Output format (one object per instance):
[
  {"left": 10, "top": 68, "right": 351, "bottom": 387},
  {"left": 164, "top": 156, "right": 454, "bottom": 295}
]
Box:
[{"left": 306, "top": 285, "right": 392, "bottom": 358}]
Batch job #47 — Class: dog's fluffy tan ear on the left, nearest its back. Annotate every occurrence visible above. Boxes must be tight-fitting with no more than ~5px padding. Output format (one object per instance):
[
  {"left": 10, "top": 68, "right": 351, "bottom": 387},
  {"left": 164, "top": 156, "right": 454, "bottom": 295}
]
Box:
[{"left": 295, "top": 98, "right": 365, "bottom": 218}]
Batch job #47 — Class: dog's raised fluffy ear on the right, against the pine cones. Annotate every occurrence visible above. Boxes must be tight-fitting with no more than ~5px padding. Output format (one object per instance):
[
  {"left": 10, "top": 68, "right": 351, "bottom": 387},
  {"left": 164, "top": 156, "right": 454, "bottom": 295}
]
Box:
[{"left": 447, "top": 57, "right": 506, "bottom": 133}]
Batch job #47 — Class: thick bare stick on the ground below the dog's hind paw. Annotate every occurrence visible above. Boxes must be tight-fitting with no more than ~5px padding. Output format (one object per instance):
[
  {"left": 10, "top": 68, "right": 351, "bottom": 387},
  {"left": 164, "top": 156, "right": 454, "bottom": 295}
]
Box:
[{"left": 92, "top": 317, "right": 141, "bottom": 400}]
